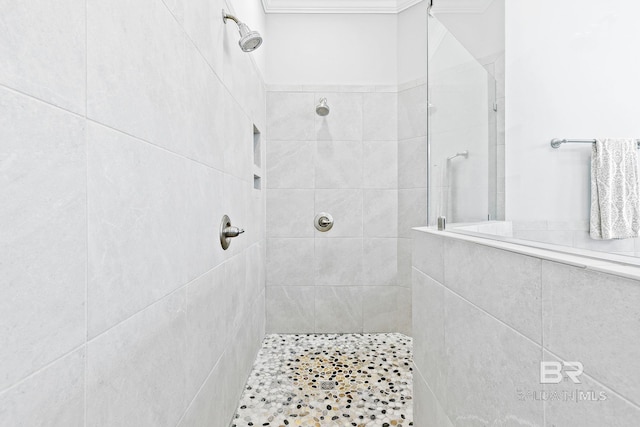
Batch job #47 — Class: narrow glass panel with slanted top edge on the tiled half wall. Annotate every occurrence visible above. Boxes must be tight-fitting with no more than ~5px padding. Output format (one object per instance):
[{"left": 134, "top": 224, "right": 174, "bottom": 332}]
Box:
[{"left": 428, "top": 17, "right": 497, "bottom": 225}]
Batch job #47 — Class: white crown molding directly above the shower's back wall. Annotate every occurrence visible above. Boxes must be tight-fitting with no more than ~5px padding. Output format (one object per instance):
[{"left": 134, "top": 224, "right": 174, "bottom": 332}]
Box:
[{"left": 262, "top": 0, "right": 428, "bottom": 14}]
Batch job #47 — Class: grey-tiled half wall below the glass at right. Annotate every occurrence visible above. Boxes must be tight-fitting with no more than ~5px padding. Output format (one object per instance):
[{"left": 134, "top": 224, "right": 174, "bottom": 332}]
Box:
[{"left": 413, "top": 231, "right": 640, "bottom": 427}]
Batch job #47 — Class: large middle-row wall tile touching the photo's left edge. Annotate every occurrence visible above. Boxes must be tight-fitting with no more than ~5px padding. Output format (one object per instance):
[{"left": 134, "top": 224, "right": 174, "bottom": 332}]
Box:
[{"left": 0, "top": 89, "right": 87, "bottom": 390}]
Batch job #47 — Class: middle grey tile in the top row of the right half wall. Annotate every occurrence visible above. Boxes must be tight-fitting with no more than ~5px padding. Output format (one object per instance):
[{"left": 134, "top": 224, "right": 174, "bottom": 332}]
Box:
[{"left": 444, "top": 239, "right": 542, "bottom": 344}]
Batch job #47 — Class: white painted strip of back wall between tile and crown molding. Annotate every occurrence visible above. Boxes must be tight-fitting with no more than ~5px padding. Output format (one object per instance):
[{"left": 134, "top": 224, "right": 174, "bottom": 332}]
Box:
[{"left": 265, "top": 14, "right": 398, "bottom": 85}]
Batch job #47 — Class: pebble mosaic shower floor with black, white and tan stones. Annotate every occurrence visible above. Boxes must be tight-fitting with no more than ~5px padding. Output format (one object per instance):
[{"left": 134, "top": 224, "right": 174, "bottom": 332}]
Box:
[{"left": 231, "top": 334, "right": 413, "bottom": 427}]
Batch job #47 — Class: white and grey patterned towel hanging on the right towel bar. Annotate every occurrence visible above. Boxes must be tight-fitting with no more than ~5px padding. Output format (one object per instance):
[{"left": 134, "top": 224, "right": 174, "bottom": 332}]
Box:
[{"left": 590, "top": 139, "right": 640, "bottom": 240}]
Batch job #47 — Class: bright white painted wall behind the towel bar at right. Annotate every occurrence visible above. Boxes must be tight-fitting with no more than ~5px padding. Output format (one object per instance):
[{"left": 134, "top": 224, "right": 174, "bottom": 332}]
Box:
[{"left": 506, "top": 0, "right": 640, "bottom": 221}]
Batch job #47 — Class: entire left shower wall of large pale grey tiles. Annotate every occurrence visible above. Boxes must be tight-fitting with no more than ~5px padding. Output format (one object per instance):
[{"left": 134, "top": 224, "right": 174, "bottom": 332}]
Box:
[{"left": 0, "top": 0, "right": 265, "bottom": 427}]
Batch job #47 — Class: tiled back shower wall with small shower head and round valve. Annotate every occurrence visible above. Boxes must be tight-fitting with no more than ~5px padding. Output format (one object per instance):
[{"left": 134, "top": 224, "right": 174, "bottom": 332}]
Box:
[{"left": 267, "top": 87, "right": 415, "bottom": 333}]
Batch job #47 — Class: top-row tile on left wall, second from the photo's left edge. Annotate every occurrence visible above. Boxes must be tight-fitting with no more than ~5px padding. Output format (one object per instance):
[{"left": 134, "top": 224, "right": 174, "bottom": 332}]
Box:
[{"left": 87, "top": 0, "right": 185, "bottom": 152}]
